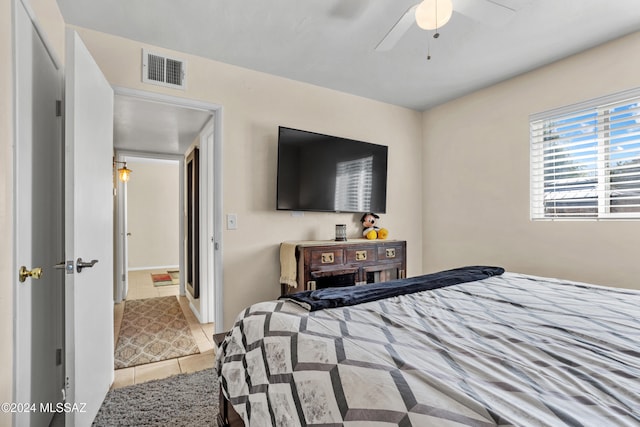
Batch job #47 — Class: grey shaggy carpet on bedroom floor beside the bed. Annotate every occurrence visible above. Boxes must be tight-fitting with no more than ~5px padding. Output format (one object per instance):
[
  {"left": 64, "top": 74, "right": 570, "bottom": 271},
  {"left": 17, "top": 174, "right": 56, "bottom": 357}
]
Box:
[{"left": 93, "top": 369, "right": 218, "bottom": 427}]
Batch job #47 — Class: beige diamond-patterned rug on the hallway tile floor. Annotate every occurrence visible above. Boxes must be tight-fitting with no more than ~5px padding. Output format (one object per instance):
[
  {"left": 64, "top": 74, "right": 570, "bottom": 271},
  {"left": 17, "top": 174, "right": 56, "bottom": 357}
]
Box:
[{"left": 115, "top": 296, "right": 200, "bottom": 369}]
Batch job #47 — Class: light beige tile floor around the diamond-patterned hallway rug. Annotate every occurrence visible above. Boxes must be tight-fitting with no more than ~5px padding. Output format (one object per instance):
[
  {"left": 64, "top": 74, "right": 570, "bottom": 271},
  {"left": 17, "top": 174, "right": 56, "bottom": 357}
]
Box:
[{"left": 112, "top": 270, "right": 215, "bottom": 388}]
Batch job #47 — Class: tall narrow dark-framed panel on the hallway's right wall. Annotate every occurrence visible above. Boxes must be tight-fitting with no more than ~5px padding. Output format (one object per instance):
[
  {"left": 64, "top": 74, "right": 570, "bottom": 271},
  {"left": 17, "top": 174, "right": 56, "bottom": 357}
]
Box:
[{"left": 186, "top": 148, "right": 200, "bottom": 298}]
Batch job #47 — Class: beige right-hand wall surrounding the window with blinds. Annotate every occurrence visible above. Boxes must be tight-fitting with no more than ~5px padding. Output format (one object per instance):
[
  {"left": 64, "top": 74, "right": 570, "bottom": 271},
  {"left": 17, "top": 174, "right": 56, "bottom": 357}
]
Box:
[{"left": 422, "top": 33, "right": 640, "bottom": 288}]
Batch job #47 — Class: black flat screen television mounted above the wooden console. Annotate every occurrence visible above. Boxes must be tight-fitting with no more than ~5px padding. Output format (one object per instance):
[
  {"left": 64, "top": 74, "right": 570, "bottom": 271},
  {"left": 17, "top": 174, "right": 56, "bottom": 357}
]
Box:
[{"left": 277, "top": 126, "right": 388, "bottom": 213}]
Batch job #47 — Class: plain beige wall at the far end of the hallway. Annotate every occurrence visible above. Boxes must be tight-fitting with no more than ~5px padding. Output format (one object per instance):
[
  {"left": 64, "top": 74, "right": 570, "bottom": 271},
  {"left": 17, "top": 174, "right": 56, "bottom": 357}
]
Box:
[{"left": 127, "top": 160, "right": 180, "bottom": 269}]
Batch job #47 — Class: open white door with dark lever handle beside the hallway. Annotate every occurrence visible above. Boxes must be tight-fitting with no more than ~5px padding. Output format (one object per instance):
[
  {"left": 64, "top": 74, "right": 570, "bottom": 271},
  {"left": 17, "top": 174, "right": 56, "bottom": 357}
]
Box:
[{"left": 65, "top": 29, "right": 113, "bottom": 426}]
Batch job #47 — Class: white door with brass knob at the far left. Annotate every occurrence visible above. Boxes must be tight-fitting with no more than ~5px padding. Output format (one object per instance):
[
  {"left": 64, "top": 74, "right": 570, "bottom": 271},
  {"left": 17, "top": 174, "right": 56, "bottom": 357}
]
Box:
[{"left": 12, "top": 2, "right": 64, "bottom": 426}]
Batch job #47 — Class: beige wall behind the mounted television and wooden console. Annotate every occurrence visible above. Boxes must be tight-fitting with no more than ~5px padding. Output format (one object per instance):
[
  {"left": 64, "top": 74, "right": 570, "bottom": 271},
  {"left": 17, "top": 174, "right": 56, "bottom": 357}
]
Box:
[{"left": 72, "top": 29, "right": 422, "bottom": 328}]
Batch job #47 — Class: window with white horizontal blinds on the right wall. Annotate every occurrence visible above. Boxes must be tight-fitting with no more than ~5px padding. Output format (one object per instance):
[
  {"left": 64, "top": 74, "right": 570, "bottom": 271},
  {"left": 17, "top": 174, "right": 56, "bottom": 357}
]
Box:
[{"left": 529, "top": 88, "right": 640, "bottom": 221}]
